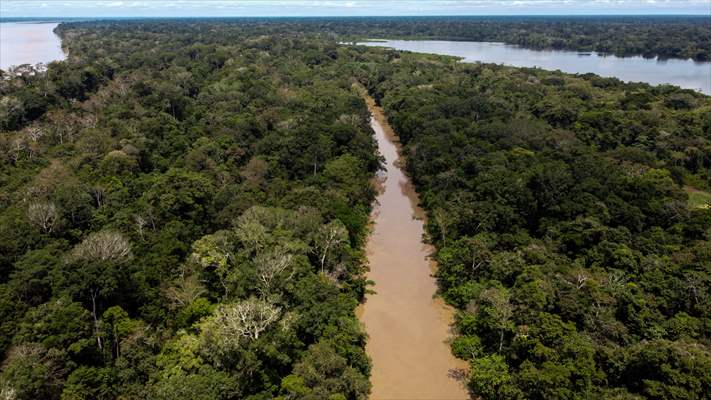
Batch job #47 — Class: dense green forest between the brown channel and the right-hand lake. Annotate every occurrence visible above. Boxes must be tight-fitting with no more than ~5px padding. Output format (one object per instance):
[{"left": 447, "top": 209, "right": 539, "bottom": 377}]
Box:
[{"left": 362, "top": 46, "right": 711, "bottom": 400}]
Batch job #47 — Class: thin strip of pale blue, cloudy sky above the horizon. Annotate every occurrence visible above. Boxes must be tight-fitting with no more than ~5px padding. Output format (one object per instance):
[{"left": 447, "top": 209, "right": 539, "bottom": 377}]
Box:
[{"left": 0, "top": 0, "right": 711, "bottom": 18}]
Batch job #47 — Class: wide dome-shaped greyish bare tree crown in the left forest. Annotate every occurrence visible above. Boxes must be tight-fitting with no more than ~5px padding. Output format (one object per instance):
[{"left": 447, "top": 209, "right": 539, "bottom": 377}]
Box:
[{"left": 72, "top": 231, "right": 131, "bottom": 262}]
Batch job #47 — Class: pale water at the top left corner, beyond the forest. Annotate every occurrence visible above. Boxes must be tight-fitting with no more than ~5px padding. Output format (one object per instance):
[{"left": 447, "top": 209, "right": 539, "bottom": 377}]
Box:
[{"left": 0, "top": 22, "right": 65, "bottom": 70}]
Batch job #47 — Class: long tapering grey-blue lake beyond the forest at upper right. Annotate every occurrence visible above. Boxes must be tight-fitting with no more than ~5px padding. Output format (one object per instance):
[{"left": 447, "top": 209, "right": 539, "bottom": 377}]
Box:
[{"left": 358, "top": 40, "right": 711, "bottom": 95}]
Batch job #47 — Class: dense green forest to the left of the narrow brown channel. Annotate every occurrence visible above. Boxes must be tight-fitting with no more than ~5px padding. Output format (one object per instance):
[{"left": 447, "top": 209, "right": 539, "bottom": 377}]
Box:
[{"left": 0, "top": 23, "right": 379, "bottom": 400}]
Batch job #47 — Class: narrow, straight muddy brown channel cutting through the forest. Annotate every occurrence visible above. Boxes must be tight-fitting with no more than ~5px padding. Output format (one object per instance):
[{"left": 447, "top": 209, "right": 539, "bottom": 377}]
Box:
[{"left": 359, "top": 92, "right": 469, "bottom": 400}]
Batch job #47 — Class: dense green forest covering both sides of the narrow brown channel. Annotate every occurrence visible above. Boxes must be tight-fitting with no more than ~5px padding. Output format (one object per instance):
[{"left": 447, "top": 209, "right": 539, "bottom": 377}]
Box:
[{"left": 0, "top": 19, "right": 711, "bottom": 400}]
